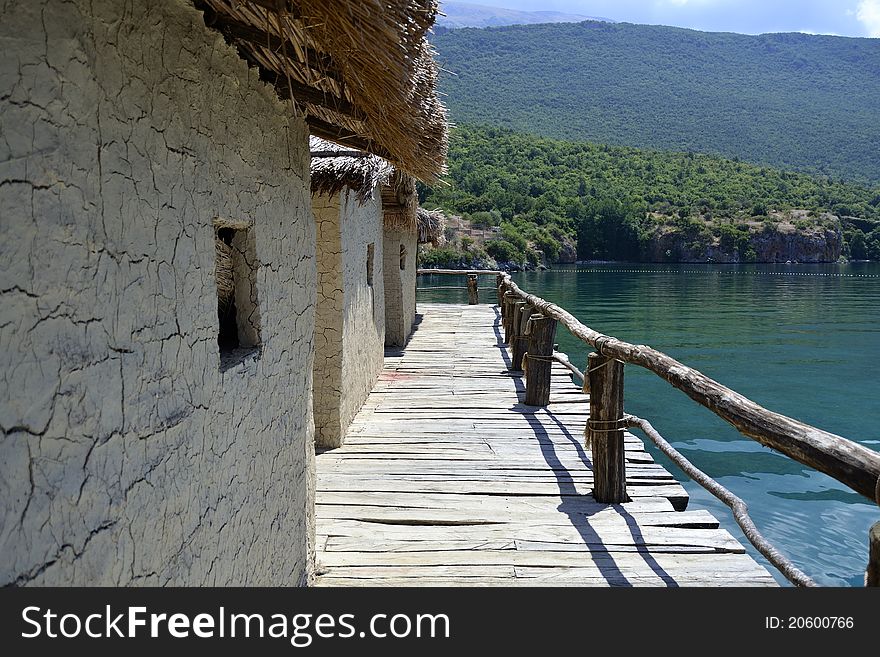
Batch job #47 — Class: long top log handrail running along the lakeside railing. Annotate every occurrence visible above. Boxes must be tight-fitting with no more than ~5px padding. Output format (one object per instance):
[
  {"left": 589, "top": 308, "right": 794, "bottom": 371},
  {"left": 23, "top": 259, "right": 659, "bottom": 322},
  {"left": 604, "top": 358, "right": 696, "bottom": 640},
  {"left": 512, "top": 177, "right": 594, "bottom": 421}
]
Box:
[{"left": 418, "top": 269, "right": 880, "bottom": 504}]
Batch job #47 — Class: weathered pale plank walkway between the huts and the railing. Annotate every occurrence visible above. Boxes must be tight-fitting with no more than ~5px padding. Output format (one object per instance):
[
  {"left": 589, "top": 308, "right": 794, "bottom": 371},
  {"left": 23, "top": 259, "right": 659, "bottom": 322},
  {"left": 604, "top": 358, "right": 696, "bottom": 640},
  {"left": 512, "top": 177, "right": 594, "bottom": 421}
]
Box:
[{"left": 317, "top": 304, "right": 775, "bottom": 586}]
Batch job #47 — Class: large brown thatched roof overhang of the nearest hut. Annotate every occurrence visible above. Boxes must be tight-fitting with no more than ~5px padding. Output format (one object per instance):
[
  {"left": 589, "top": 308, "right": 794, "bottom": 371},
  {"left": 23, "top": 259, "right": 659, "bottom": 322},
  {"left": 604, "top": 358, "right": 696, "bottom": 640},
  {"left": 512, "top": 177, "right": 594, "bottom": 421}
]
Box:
[{"left": 194, "top": 0, "right": 447, "bottom": 181}]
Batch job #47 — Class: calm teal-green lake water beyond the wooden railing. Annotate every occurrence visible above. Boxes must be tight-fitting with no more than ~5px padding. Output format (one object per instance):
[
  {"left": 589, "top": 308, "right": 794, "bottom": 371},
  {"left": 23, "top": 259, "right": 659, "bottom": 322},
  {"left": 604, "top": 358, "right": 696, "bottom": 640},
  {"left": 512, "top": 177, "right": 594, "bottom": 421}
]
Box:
[{"left": 418, "top": 263, "right": 880, "bottom": 586}]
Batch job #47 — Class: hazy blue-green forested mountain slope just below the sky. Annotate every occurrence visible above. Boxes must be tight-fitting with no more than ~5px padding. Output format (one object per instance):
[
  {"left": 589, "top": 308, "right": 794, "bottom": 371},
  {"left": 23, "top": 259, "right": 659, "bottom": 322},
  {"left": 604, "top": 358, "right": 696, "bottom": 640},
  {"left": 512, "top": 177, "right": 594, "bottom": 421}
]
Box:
[{"left": 433, "top": 22, "right": 880, "bottom": 183}]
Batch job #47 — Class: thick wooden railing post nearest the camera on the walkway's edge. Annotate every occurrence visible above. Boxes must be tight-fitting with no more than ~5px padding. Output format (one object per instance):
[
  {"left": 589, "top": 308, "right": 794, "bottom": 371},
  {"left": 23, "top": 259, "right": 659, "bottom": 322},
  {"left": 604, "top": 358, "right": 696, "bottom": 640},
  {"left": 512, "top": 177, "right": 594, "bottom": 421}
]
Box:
[{"left": 587, "top": 353, "right": 629, "bottom": 504}]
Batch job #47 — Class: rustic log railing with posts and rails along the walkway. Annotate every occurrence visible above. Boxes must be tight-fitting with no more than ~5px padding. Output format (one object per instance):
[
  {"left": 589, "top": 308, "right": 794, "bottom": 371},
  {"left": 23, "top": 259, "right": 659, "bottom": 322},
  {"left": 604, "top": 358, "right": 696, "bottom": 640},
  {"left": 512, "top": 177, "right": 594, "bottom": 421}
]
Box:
[{"left": 419, "top": 269, "right": 880, "bottom": 586}]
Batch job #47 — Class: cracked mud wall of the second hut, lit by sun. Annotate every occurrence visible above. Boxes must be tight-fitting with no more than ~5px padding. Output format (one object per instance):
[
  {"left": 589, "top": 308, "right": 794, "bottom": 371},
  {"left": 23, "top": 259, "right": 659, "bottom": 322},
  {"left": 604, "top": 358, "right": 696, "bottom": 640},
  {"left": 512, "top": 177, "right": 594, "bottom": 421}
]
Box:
[{"left": 312, "top": 189, "right": 385, "bottom": 447}]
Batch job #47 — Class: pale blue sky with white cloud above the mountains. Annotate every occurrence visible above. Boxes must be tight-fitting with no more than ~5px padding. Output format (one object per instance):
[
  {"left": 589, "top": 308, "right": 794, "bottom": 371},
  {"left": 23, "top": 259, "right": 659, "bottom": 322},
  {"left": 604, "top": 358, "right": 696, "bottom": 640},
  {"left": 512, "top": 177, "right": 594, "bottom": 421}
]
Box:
[{"left": 462, "top": 0, "right": 880, "bottom": 37}]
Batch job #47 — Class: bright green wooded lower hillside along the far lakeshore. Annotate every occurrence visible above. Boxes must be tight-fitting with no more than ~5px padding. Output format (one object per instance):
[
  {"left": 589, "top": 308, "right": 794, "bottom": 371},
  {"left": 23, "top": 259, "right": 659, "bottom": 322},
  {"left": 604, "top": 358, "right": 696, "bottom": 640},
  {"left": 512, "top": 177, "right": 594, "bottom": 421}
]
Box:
[{"left": 420, "top": 126, "right": 880, "bottom": 264}]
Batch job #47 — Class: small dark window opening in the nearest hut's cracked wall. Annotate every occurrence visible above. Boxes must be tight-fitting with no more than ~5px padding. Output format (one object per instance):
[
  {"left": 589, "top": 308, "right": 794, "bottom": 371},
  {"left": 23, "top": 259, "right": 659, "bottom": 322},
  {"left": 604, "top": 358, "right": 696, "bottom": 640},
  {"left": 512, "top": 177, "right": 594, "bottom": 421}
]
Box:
[{"left": 214, "top": 219, "right": 260, "bottom": 371}]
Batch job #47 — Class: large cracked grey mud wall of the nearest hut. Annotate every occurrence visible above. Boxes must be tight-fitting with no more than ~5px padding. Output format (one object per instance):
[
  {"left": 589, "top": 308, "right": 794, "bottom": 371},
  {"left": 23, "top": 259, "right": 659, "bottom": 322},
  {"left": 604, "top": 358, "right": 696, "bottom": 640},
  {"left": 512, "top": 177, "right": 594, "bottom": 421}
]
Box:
[{"left": 0, "top": 0, "right": 316, "bottom": 585}]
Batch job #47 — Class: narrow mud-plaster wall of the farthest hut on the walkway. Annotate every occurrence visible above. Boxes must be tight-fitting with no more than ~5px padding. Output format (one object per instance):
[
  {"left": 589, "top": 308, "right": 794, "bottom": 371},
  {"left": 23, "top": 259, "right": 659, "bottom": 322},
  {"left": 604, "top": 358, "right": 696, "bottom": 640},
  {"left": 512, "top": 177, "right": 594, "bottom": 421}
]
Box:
[{"left": 383, "top": 228, "right": 418, "bottom": 347}]
